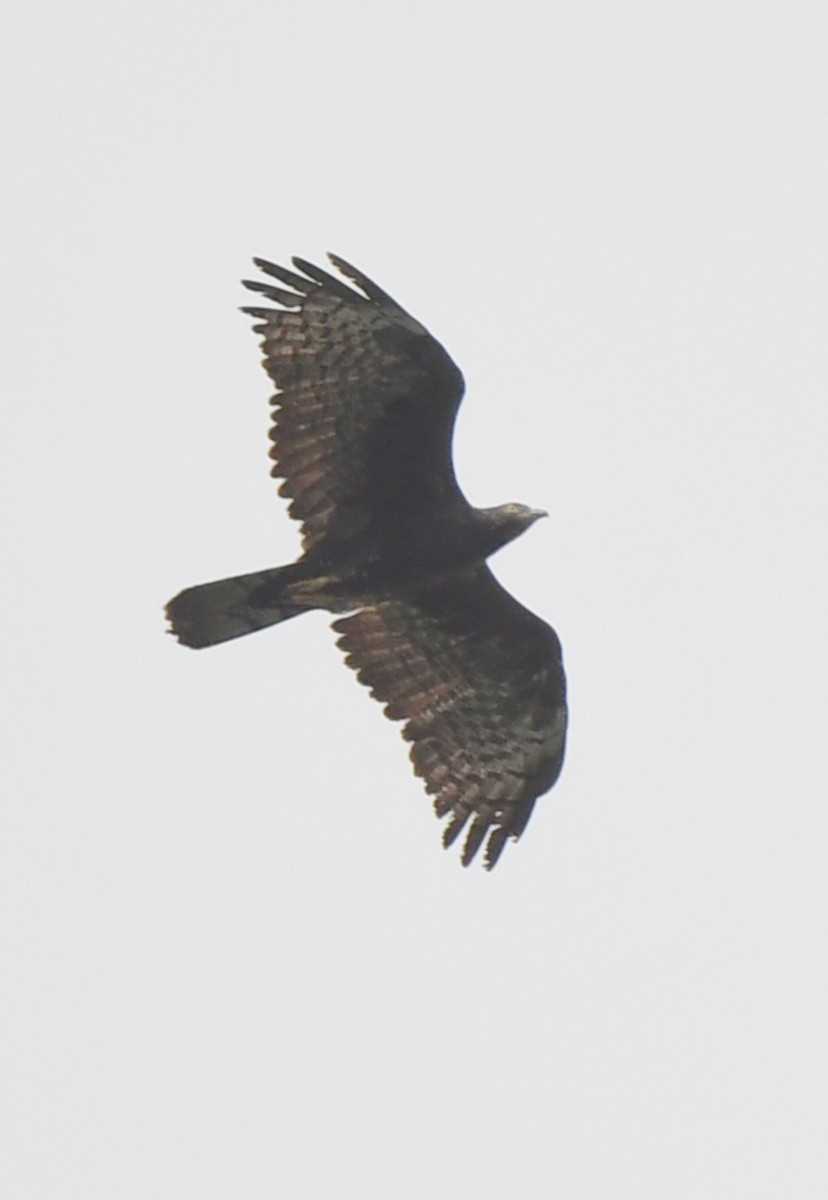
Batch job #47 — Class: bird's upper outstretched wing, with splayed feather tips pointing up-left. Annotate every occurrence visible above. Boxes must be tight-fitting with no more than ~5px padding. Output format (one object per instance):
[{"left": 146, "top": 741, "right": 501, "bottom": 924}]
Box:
[{"left": 244, "top": 254, "right": 466, "bottom": 557}]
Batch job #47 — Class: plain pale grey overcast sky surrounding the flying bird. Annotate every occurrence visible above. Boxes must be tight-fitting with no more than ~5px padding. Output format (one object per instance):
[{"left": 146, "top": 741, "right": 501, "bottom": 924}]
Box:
[{"left": 0, "top": 0, "right": 828, "bottom": 1200}]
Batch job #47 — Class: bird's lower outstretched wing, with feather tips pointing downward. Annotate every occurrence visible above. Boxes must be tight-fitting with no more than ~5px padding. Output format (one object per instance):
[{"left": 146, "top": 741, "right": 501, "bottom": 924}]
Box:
[{"left": 334, "top": 566, "right": 566, "bottom": 869}]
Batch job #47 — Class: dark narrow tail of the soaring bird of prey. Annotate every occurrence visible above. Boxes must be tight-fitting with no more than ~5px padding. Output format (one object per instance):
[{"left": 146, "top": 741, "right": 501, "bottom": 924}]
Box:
[{"left": 166, "top": 563, "right": 316, "bottom": 649}]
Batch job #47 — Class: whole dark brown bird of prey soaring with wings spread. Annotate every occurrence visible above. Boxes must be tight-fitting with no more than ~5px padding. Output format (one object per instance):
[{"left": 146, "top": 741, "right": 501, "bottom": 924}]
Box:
[{"left": 167, "top": 254, "right": 566, "bottom": 869}]
